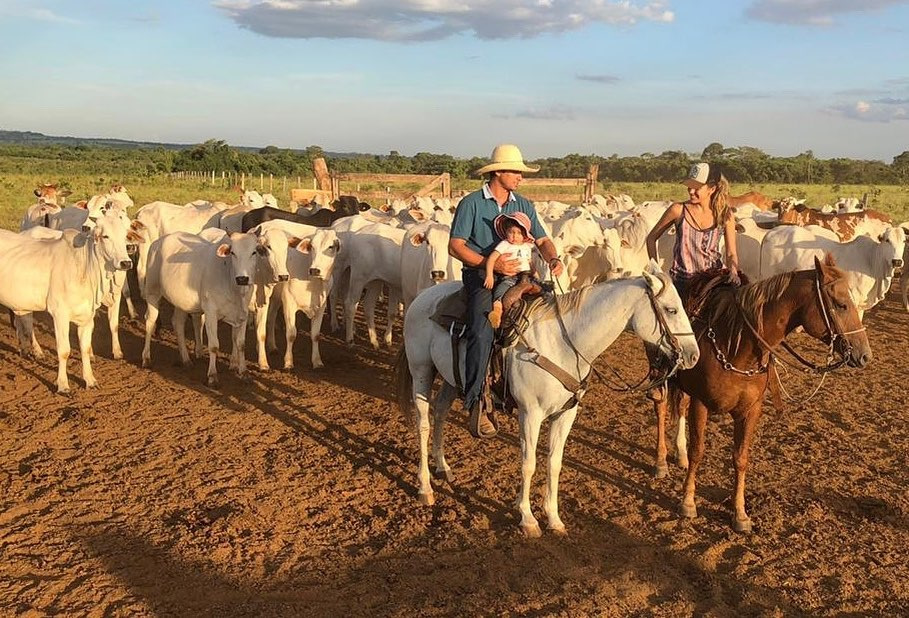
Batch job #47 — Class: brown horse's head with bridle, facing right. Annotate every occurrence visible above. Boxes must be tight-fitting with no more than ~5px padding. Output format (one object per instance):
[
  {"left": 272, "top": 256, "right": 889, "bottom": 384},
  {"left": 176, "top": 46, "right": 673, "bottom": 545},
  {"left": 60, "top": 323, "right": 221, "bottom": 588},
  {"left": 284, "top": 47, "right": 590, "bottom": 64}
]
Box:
[{"left": 802, "top": 253, "right": 871, "bottom": 367}]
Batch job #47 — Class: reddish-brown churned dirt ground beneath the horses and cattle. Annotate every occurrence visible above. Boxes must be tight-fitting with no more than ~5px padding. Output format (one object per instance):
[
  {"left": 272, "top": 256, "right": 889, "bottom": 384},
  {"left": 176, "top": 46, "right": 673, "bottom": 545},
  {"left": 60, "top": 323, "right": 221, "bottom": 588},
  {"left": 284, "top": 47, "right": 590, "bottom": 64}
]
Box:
[{"left": 0, "top": 294, "right": 909, "bottom": 616}]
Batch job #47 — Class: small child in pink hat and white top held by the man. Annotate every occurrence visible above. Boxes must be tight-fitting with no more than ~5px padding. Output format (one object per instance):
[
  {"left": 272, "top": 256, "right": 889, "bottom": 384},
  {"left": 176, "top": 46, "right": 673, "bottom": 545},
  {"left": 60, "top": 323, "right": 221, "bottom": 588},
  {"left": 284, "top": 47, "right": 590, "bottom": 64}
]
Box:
[{"left": 483, "top": 212, "right": 539, "bottom": 328}]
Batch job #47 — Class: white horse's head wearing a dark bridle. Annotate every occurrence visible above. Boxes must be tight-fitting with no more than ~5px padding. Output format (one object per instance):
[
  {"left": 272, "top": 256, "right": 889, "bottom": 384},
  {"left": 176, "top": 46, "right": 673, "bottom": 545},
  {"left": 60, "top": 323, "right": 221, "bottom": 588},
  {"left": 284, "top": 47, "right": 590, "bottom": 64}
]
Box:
[{"left": 633, "top": 260, "right": 700, "bottom": 369}]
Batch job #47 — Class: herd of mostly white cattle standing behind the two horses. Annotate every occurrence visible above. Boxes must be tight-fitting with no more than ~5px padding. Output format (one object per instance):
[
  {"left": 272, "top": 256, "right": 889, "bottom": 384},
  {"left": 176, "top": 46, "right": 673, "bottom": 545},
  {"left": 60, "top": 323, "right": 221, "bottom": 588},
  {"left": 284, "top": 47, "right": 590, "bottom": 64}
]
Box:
[{"left": 0, "top": 185, "right": 909, "bottom": 392}]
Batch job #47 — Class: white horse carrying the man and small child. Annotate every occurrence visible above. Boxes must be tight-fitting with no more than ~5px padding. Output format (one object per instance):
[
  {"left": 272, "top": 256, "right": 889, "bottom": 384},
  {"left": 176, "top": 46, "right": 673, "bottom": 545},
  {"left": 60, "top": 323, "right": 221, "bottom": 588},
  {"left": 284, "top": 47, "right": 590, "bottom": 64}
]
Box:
[{"left": 397, "top": 262, "right": 698, "bottom": 537}]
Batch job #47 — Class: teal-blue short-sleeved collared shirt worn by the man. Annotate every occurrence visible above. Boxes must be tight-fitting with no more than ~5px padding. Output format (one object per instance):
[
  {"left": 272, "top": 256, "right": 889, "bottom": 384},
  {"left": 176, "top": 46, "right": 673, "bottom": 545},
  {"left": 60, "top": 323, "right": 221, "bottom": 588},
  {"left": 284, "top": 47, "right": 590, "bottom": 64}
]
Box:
[{"left": 451, "top": 183, "right": 546, "bottom": 257}]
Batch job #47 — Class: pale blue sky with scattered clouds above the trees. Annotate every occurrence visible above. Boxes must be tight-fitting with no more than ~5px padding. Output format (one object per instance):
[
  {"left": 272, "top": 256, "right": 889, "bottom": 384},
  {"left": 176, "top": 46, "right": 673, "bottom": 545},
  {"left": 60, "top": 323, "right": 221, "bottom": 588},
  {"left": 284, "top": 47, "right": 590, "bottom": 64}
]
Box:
[{"left": 0, "top": 0, "right": 909, "bottom": 162}]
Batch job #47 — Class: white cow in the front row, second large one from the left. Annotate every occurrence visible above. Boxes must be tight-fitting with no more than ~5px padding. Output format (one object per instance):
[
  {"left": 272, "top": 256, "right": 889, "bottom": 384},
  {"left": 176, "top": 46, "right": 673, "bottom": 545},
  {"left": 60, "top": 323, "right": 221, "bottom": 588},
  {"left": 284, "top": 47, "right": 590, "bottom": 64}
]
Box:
[{"left": 142, "top": 232, "right": 277, "bottom": 386}]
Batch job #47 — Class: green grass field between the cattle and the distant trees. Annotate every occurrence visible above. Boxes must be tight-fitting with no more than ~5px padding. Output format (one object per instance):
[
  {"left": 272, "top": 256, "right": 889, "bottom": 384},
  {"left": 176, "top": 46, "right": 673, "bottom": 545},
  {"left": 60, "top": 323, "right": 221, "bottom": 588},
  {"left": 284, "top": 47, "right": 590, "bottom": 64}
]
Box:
[{"left": 0, "top": 169, "right": 909, "bottom": 230}]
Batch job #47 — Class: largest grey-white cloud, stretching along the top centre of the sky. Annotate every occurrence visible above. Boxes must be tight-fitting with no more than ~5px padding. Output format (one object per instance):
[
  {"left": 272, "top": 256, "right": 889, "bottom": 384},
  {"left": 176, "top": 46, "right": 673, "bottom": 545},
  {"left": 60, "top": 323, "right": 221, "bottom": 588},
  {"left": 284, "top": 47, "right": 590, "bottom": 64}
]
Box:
[{"left": 213, "top": 0, "right": 675, "bottom": 41}]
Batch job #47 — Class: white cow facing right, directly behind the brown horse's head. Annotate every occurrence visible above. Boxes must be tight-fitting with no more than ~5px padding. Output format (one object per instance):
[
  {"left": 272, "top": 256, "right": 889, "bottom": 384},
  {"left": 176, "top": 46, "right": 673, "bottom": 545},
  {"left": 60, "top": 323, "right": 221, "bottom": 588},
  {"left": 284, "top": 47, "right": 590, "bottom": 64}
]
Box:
[{"left": 761, "top": 225, "right": 906, "bottom": 316}]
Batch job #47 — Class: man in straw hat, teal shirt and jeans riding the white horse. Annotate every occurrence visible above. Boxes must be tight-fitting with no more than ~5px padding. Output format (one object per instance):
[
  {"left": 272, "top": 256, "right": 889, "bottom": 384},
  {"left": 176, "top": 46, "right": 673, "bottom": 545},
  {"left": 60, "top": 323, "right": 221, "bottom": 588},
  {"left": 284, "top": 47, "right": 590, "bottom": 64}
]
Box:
[{"left": 448, "top": 144, "right": 562, "bottom": 438}]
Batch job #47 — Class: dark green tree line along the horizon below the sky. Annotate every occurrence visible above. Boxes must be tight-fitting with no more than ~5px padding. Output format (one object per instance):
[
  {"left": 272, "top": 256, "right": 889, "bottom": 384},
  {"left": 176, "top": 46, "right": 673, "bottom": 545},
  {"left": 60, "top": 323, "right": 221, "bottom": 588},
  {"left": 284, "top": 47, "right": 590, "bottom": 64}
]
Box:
[{"left": 0, "top": 139, "right": 909, "bottom": 185}]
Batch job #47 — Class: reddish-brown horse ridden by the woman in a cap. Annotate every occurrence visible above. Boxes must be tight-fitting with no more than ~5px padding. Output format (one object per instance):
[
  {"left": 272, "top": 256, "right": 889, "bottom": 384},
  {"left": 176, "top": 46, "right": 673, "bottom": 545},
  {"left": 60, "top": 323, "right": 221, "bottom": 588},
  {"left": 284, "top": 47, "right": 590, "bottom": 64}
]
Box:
[{"left": 654, "top": 254, "right": 871, "bottom": 532}]
